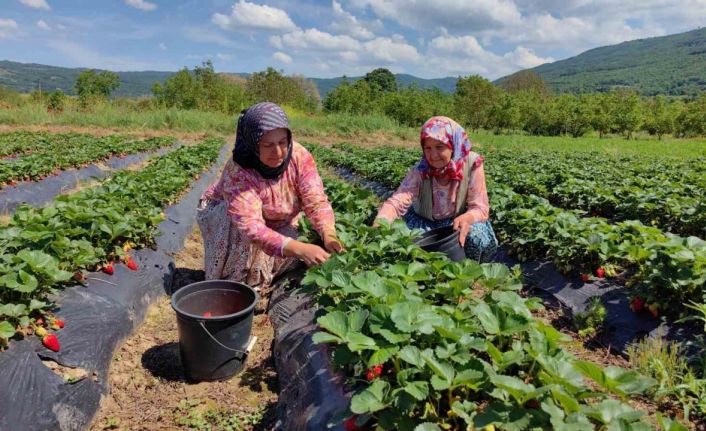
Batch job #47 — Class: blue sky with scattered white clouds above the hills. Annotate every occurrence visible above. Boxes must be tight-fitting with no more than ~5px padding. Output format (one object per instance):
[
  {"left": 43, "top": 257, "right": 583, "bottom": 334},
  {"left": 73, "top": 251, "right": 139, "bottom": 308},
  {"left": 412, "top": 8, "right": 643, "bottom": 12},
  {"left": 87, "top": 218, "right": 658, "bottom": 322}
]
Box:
[{"left": 0, "top": 0, "right": 706, "bottom": 79}]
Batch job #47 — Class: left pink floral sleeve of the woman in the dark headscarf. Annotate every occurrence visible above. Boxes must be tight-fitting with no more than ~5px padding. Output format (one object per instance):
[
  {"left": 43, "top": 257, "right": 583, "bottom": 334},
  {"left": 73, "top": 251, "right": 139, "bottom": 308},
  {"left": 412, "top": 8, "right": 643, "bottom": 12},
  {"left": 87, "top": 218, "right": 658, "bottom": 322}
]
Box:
[{"left": 223, "top": 172, "right": 287, "bottom": 256}]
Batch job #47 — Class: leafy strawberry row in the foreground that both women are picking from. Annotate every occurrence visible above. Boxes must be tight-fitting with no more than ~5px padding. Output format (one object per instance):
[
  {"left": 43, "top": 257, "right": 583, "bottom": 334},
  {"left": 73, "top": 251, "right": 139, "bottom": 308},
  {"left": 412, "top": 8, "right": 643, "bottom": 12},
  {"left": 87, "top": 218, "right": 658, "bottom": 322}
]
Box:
[{"left": 302, "top": 176, "right": 684, "bottom": 431}]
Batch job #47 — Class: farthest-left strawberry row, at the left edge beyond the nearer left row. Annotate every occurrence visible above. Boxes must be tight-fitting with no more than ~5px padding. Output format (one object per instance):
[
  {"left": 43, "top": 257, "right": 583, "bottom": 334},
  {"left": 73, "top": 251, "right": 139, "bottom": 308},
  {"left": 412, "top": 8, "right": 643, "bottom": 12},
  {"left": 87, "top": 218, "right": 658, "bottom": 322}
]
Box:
[{"left": 0, "top": 132, "right": 174, "bottom": 185}]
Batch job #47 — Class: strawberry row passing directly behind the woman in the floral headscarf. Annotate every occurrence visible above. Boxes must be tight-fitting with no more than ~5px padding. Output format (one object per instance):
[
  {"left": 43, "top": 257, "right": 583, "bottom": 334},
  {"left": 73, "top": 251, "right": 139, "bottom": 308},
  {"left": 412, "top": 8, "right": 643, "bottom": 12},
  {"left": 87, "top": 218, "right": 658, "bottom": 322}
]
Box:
[{"left": 306, "top": 143, "right": 706, "bottom": 318}]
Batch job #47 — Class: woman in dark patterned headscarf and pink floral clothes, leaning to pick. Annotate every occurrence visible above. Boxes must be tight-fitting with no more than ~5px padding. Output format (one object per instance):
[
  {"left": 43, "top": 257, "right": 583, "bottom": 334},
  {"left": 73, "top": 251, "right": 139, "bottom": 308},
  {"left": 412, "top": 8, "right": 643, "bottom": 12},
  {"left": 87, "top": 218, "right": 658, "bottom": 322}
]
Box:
[{"left": 197, "top": 103, "right": 343, "bottom": 288}]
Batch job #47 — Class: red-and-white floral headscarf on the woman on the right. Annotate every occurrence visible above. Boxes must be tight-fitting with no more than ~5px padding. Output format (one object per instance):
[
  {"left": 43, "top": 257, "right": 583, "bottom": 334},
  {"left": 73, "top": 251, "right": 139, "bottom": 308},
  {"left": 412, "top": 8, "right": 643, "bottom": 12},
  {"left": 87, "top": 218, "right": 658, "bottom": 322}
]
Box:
[{"left": 417, "top": 117, "right": 472, "bottom": 181}]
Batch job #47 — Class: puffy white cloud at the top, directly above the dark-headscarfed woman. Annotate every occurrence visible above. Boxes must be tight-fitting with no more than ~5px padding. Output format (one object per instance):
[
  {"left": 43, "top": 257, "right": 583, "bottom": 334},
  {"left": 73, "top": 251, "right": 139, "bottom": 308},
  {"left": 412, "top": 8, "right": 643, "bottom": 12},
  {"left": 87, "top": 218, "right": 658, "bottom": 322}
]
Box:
[{"left": 211, "top": 0, "right": 297, "bottom": 33}]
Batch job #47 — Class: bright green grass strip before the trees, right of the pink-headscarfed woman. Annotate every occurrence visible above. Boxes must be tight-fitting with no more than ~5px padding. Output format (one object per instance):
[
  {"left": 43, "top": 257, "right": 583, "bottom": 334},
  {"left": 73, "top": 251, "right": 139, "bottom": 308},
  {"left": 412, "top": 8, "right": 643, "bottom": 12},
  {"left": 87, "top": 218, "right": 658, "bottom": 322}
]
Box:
[{"left": 470, "top": 132, "right": 706, "bottom": 158}]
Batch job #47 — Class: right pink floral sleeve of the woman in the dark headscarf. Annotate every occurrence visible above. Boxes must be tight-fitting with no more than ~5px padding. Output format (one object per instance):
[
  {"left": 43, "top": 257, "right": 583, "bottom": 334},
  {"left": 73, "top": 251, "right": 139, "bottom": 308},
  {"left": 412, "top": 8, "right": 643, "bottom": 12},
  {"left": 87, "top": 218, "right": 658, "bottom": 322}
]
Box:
[{"left": 297, "top": 148, "right": 336, "bottom": 237}]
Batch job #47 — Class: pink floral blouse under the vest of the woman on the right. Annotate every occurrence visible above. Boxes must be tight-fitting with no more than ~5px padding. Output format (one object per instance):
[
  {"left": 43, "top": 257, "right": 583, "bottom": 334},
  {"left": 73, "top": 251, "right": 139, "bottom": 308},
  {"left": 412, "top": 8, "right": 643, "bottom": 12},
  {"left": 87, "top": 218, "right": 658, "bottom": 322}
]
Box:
[{"left": 377, "top": 158, "right": 490, "bottom": 223}]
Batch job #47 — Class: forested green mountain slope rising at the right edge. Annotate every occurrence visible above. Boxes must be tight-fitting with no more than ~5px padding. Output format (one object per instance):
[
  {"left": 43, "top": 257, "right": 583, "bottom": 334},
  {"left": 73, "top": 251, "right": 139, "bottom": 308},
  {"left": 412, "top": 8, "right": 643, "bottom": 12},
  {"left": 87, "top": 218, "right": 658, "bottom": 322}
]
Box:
[{"left": 495, "top": 28, "right": 706, "bottom": 96}]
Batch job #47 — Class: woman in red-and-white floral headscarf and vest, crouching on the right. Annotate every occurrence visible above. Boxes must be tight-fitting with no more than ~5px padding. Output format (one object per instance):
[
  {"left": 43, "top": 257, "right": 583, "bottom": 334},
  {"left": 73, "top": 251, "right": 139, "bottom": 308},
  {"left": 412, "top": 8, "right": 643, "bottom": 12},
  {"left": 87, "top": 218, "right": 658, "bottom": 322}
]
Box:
[{"left": 377, "top": 117, "right": 498, "bottom": 261}]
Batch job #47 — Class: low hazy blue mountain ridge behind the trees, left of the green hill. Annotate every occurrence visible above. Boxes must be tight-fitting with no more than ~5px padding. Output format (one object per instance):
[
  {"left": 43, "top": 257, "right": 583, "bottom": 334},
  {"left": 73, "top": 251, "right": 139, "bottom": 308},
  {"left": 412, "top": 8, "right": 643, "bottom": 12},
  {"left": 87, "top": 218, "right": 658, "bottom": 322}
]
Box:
[{"left": 0, "top": 61, "right": 456, "bottom": 98}]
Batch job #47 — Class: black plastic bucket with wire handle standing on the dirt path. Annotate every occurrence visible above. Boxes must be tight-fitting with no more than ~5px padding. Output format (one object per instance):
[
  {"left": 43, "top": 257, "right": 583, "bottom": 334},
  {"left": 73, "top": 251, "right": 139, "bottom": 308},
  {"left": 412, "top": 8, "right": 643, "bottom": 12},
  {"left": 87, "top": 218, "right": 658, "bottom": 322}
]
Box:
[{"left": 172, "top": 280, "right": 259, "bottom": 381}]
